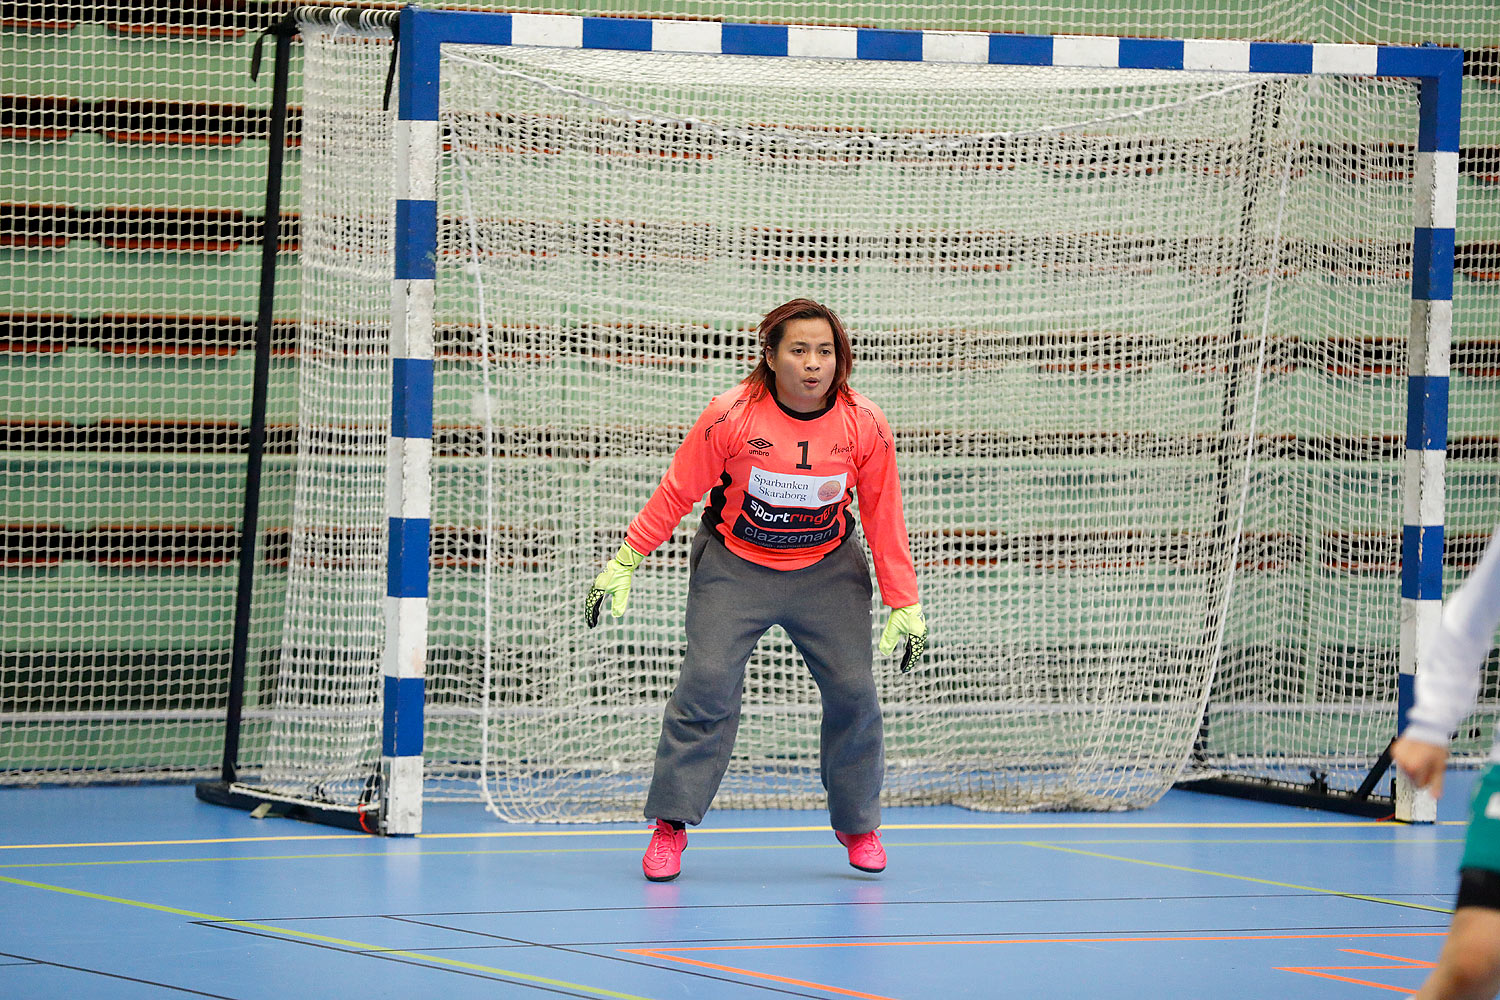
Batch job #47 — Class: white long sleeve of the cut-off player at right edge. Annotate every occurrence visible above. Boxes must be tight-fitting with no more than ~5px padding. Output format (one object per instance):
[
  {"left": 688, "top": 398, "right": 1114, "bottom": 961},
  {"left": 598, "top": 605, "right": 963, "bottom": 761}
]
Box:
[{"left": 1404, "top": 528, "right": 1500, "bottom": 762}]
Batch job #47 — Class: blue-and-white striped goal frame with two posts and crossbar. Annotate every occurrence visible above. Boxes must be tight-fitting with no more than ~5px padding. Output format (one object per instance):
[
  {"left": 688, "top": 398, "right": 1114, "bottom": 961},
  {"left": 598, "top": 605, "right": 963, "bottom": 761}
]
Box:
[{"left": 283, "top": 6, "right": 1463, "bottom": 835}]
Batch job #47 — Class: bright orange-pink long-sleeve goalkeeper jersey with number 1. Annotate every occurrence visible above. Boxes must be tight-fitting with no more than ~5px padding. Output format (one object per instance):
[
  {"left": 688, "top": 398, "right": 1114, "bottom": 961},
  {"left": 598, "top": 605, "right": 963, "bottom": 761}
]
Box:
[{"left": 626, "top": 384, "right": 917, "bottom": 607}]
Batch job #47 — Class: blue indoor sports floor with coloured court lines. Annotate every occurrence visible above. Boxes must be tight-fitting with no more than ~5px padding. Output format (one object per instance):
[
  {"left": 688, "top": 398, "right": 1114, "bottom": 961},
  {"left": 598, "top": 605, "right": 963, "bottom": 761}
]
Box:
[{"left": 0, "top": 772, "right": 1475, "bottom": 1000}]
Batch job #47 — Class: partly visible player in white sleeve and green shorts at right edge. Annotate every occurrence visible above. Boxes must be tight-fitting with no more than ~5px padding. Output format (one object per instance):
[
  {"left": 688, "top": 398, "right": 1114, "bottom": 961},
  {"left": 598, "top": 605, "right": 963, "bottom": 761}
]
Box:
[{"left": 1391, "top": 529, "right": 1500, "bottom": 1000}]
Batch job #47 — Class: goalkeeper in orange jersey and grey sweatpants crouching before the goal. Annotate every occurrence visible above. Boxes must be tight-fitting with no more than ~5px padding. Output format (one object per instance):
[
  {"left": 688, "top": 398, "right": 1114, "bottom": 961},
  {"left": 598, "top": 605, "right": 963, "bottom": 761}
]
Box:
[{"left": 585, "top": 298, "right": 927, "bottom": 882}]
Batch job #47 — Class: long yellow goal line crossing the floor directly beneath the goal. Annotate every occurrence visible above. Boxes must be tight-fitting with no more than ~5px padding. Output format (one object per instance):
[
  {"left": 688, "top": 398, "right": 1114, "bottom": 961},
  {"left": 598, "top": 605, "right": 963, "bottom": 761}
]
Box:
[{"left": 0, "top": 820, "right": 1469, "bottom": 850}]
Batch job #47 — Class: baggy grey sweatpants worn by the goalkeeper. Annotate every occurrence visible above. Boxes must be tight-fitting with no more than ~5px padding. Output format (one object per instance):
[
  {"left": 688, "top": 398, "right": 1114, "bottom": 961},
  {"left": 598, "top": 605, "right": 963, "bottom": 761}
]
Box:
[{"left": 645, "top": 528, "right": 885, "bottom": 834}]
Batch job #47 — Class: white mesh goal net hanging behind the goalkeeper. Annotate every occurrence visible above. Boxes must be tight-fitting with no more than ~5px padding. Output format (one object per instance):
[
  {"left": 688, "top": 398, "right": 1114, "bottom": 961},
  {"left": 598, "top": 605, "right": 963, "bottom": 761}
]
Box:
[{"left": 261, "top": 17, "right": 1418, "bottom": 820}]
